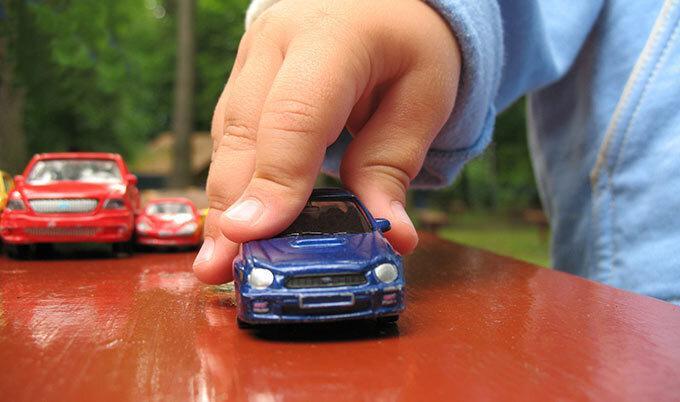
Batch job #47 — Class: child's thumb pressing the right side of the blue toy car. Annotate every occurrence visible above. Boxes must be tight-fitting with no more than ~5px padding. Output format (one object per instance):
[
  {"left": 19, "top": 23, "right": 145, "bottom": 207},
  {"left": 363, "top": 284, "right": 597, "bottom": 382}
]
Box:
[{"left": 340, "top": 72, "right": 453, "bottom": 254}]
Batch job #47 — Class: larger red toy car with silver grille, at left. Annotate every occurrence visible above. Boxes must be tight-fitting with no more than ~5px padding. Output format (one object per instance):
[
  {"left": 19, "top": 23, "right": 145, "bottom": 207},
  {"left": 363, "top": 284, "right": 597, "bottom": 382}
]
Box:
[{"left": 0, "top": 152, "right": 139, "bottom": 257}]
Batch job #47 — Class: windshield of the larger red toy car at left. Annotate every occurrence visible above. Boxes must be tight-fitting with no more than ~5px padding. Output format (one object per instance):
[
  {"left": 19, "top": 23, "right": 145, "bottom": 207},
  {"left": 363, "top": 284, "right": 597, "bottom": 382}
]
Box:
[{"left": 26, "top": 159, "right": 122, "bottom": 184}]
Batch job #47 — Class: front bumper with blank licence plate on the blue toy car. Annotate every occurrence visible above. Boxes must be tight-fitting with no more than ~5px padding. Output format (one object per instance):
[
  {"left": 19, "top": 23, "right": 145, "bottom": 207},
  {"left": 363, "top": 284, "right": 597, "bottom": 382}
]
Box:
[{"left": 237, "top": 285, "right": 404, "bottom": 324}]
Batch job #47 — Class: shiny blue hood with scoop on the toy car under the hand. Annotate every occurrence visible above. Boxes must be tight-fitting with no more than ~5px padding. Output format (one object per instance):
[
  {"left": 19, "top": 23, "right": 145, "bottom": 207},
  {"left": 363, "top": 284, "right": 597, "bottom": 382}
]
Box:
[{"left": 243, "top": 232, "right": 392, "bottom": 272}]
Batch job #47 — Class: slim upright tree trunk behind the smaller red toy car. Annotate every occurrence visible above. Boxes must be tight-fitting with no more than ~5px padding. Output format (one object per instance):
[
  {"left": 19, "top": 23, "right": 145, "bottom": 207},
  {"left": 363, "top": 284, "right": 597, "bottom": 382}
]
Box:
[{"left": 170, "top": 0, "right": 195, "bottom": 187}]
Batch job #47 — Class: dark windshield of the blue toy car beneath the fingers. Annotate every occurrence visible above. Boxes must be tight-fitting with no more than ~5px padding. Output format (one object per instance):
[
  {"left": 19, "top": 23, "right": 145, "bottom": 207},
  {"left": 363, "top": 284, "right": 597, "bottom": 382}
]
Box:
[{"left": 276, "top": 200, "right": 371, "bottom": 237}]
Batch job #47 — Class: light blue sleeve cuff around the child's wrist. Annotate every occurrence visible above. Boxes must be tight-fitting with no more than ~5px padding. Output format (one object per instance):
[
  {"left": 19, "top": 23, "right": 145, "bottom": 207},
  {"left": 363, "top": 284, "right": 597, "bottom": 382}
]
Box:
[{"left": 413, "top": 0, "right": 503, "bottom": 188}]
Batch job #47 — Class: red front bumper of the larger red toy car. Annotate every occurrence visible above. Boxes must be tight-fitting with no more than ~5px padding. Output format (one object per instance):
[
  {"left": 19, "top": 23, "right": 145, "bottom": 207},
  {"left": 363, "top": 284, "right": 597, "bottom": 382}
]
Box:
[{"left": 0, "top": 211, "right": 134, "bottom": 244}]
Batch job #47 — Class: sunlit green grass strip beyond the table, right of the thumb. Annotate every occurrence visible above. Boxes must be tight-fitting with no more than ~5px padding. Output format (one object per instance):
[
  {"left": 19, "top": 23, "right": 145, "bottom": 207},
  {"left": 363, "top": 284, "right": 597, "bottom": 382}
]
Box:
[{"left": 438, "top": 212, "right": 550, "bottom": 267}]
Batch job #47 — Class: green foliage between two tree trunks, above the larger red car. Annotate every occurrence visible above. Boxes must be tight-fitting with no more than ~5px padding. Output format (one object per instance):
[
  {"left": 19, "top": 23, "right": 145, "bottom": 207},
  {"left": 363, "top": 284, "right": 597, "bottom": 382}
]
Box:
[{"left": 12, "top": 0, "right": 173, "bottom": 154}]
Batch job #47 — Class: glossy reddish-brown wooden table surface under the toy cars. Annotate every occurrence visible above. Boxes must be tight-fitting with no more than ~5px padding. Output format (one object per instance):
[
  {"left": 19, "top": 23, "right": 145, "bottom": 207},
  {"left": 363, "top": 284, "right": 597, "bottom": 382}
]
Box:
[{"left": 0, "top": 234, "right": 680, "bottom": 402}]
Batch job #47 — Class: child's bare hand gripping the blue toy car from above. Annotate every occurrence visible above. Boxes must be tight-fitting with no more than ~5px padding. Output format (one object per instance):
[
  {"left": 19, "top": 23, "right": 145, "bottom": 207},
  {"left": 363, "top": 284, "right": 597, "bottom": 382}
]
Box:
[{"left": 194, "top": 0, "right": 460, "bottom": 283}]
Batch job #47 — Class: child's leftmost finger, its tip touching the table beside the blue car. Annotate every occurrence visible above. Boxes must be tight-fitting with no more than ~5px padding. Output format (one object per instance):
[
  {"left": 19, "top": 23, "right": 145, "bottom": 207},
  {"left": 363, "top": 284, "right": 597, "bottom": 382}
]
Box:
[{"left": 194, "top": 36, "right": 282, "bottom": 283}]
